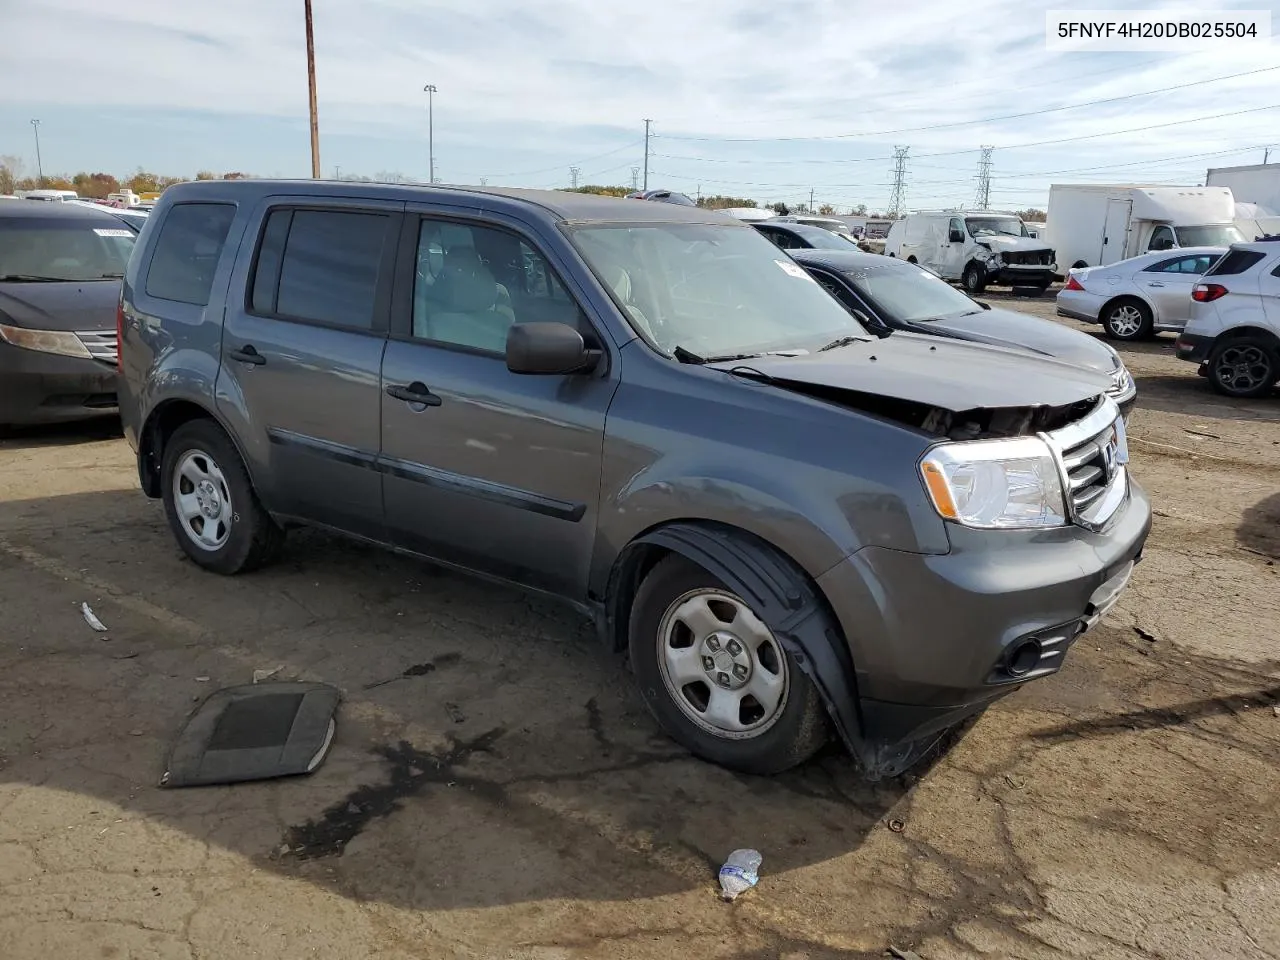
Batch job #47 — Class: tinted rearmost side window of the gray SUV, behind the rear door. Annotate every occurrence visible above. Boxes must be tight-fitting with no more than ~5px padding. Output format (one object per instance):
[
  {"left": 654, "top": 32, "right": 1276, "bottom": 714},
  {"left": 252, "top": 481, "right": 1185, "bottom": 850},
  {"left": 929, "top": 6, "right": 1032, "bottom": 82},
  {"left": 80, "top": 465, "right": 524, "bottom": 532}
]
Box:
[{"left": 146, "top": 204, "right": 236, "bottom": 307}]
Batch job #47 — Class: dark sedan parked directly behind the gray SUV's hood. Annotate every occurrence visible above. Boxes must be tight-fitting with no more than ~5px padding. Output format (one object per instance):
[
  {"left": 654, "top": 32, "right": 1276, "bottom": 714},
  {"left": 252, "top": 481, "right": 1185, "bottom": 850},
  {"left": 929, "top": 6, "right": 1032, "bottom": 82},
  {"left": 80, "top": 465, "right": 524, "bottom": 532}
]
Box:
[{"left": 791, "top": 250, "right": 1138, "bottom": 417}]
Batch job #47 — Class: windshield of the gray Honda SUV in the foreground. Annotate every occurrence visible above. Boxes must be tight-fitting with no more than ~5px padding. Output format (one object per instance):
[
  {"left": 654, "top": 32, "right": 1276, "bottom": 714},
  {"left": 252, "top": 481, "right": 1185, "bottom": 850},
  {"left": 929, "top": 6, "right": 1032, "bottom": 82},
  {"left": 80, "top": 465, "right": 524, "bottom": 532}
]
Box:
[{"left": 571, "top": 223, "right": 868, "bottom": 360}]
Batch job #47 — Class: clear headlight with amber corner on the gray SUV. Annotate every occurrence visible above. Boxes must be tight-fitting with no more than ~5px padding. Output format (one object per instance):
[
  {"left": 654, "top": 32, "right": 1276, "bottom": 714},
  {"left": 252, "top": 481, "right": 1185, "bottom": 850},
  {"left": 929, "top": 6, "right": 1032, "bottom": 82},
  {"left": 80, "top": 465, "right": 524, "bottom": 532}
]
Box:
[{"left": 920, "top": 436, "right": 1066, "bottom": 530}]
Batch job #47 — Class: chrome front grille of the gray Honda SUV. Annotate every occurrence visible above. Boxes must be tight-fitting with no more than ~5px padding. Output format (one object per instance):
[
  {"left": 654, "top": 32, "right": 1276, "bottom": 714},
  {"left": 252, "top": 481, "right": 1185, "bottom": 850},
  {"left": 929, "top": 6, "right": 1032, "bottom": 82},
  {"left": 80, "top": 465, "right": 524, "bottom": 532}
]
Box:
[{"left": 1046, "top": 399, "right": 1129, "bottom": 527}]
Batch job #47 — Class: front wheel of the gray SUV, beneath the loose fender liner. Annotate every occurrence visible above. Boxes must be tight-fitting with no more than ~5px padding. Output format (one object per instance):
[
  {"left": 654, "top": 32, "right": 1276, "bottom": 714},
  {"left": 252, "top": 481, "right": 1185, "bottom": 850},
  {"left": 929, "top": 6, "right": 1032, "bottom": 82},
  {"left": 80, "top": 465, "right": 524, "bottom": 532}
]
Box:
[{"left": 630, "top": 554, "right": 827, "bottom": 774}]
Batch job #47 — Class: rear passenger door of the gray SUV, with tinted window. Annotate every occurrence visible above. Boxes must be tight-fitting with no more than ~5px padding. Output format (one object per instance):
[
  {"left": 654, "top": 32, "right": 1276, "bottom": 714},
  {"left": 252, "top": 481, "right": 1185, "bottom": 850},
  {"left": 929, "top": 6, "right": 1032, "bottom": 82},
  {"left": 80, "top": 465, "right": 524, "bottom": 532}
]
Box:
[{"left": 218, "top": 197, "right": 404, "bottom": 539}]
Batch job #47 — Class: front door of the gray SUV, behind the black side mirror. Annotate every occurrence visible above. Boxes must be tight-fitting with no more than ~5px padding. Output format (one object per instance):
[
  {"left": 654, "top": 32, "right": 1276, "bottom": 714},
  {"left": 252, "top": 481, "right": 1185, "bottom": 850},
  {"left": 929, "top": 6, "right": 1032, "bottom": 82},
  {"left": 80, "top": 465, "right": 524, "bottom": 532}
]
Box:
[{"left": 379, "top": 211, "right": 617, "bottom": 598}]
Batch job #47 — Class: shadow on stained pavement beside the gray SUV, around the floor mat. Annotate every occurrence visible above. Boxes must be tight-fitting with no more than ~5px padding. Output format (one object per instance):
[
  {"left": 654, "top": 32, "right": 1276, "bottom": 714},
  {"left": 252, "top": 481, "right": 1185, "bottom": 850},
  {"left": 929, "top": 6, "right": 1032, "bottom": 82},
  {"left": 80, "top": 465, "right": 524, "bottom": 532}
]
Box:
[{"left": 0, "top": 492, "right": 931, "bottom": 909}]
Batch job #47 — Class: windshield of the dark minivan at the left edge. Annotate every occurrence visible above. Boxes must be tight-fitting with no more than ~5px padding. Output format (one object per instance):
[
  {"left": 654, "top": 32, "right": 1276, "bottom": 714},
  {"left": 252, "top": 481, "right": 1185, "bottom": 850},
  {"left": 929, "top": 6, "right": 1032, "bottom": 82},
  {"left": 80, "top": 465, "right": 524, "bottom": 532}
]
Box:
[{"left": 0, "top": 218, "right": 136, "bottom": 282}]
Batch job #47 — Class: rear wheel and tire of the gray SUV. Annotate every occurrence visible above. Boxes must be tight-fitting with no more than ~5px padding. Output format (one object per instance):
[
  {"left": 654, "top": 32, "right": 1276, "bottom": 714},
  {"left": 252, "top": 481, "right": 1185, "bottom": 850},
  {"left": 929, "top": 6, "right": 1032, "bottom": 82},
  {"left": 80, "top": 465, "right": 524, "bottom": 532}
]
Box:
[{"left": 160, "top": 420, "right": 284, "bottom": 576}]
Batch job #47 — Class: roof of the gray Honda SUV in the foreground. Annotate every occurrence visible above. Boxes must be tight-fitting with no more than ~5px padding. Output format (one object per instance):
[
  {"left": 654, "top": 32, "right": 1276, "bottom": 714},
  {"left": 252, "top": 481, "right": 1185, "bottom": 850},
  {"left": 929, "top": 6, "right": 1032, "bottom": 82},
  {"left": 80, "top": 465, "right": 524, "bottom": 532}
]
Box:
[{"left": 163, "top": 179, "right": 745, "bottom": 227}]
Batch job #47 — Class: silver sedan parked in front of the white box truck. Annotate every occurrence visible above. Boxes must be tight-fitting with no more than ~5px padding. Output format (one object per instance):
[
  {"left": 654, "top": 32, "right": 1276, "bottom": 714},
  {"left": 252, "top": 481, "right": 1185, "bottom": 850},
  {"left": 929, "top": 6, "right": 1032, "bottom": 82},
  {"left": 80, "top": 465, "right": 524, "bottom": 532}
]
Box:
[{"left": 1057, "top": 247, "right": 1226, "bottom": 340}]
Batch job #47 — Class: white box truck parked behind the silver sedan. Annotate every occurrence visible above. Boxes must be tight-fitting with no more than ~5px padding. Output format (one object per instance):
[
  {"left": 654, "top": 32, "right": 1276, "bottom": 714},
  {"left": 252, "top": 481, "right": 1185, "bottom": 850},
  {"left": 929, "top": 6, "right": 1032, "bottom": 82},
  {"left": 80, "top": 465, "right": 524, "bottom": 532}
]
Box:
[{"left": 1046, "top": 183, "right": 1244, "bottom": 274}]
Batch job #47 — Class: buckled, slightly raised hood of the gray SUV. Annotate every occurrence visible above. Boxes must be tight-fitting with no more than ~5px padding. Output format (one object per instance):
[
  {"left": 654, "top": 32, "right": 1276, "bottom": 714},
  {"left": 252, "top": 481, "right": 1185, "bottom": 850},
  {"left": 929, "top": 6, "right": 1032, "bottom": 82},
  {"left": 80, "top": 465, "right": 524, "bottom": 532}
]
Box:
[{"left": 709, "top": 333, "right": 1110, "bottom": 412}]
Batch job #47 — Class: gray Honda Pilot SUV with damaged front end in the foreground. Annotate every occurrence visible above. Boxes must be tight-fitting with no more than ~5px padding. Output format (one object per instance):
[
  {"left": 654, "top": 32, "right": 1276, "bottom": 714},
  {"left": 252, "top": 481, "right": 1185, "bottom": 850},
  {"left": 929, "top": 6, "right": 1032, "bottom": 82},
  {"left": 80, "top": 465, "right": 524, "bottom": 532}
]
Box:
[{"left": 119, "top": 180, "right": 1151, "bottom": 777}]
